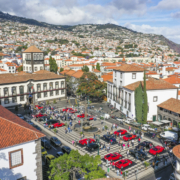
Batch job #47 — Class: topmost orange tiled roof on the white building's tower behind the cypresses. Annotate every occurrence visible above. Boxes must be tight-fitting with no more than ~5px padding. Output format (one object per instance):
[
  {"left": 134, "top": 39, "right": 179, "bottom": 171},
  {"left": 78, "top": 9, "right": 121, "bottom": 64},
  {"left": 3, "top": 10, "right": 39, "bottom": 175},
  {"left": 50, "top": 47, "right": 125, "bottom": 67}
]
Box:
[{"left": 114, "top": 64, "right": 144, "bottom": 72}]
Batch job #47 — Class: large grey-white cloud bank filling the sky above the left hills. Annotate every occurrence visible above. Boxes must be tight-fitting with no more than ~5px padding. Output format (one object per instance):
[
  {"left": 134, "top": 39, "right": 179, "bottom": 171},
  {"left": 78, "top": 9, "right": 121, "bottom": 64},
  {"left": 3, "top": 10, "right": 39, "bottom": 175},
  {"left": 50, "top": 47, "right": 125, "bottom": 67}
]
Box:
[{"left": 0, "top": 0, "right": 149, "bottom": 25}]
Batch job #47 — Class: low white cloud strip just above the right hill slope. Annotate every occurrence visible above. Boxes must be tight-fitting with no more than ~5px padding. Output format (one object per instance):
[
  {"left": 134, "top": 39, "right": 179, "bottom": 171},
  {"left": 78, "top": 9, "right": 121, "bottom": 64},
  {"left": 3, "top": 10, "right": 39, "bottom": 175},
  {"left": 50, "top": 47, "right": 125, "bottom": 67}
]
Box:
[{"left": 125, "top": 23, "right": 180, "bottom": 44}]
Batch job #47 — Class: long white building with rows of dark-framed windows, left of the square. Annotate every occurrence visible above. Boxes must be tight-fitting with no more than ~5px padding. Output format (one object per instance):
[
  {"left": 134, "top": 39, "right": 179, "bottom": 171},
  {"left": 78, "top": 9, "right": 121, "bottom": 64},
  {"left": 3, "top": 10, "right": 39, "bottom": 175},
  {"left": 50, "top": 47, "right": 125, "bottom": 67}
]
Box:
[{"left": 0, "top": 70, "right": 66, "bottom": 107}]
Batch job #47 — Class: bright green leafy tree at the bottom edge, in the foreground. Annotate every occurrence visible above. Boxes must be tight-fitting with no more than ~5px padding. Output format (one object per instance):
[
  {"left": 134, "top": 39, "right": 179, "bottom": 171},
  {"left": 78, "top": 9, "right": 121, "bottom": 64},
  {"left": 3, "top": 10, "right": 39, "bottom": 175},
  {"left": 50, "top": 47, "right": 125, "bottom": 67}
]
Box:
[{"left": 49, "top": 150, "right": 105, "bottom": 180}]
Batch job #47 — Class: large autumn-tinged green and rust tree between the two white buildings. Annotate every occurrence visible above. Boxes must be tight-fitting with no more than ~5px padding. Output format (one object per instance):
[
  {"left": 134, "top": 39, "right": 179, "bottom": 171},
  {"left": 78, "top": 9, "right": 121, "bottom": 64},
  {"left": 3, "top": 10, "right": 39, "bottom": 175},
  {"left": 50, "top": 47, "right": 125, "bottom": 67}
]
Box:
[{"left": 76, "top": 72, "right": 107, "bottom": 97}]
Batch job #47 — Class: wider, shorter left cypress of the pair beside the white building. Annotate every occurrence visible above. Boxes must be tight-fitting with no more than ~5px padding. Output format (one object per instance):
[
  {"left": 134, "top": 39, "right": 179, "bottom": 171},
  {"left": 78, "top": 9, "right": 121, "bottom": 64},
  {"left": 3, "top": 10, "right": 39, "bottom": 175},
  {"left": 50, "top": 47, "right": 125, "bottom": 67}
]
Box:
[{"left": 135, "top": 83, "right": 143, "bottom": 122}]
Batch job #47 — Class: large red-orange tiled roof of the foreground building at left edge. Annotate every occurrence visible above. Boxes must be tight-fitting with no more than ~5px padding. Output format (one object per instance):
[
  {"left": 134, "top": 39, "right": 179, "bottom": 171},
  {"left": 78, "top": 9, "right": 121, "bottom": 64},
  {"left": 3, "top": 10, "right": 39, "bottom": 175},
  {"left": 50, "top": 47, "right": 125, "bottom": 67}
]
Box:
[{"left": 0, "top": 106, "right": 45, "bottom": 149}]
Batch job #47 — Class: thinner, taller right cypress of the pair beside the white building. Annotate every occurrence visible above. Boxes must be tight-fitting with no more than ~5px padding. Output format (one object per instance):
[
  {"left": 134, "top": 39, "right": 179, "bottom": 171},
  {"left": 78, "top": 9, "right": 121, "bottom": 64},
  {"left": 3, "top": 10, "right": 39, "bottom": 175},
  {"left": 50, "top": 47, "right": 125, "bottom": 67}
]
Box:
[{"left": 142, "top": 71, "right": 148, "bottom": 123}]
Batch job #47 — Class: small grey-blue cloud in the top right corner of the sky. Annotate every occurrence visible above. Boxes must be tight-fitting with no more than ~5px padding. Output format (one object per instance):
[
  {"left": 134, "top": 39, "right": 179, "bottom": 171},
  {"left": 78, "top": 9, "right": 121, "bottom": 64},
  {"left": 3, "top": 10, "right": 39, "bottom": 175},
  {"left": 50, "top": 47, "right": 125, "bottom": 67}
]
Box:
[{"left": 153, "top": 0, "right": 180, "bottom": 10}]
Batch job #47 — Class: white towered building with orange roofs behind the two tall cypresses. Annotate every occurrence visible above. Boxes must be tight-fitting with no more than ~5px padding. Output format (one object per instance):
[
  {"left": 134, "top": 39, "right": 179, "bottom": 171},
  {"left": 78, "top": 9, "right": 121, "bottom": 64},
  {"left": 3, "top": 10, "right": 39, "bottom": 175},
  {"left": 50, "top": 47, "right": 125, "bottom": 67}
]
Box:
[{"left": 107, "top": 64, "right": 178, "bottom": 121}]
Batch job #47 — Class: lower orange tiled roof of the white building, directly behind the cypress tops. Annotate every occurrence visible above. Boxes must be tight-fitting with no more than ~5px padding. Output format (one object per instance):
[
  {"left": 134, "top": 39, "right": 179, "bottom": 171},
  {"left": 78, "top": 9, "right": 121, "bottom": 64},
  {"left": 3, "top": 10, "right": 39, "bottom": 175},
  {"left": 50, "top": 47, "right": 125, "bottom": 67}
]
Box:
[{"left": 124, "top": 78, "right": 178, "bottom": 91}]
